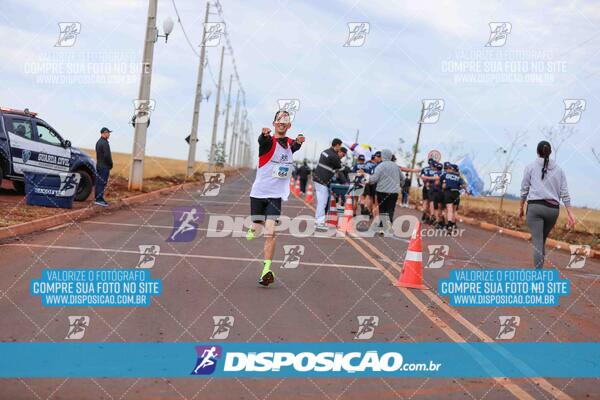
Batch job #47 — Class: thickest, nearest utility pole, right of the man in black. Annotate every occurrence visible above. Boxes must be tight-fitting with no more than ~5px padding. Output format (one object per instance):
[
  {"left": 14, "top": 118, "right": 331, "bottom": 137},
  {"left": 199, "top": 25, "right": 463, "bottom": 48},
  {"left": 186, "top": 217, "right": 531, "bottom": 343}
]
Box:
[{"left": 129, "top": 0, "right": 158, "bottom": 190}]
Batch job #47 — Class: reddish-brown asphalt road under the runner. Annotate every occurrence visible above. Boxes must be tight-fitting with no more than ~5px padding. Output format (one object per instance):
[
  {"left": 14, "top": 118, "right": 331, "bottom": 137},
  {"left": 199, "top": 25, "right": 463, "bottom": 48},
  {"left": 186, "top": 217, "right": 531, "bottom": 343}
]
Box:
[{"left": 0, "top": 172, "right": 600, "bottom": 399}]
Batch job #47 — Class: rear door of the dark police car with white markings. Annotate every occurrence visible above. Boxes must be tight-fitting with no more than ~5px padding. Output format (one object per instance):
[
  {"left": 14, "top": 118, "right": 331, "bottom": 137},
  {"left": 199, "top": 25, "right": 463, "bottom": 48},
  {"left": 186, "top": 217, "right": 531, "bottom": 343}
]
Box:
[{"left": 4, "top": 116, "right": 37, "bottom": 174}]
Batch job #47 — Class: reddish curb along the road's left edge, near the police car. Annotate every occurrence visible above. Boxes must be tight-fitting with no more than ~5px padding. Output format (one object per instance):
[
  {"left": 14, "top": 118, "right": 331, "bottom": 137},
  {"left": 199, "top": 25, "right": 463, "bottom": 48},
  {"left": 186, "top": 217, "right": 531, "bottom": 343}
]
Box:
[{"left": 0, "top": 182, "right": 202, "bottom": 240}]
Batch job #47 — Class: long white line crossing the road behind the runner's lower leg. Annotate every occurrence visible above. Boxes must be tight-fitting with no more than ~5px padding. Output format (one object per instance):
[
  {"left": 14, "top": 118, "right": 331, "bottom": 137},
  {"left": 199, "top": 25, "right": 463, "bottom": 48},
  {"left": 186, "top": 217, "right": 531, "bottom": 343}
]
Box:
[{"left": 0, "top": 243, "right": 378, "bottom": 271}]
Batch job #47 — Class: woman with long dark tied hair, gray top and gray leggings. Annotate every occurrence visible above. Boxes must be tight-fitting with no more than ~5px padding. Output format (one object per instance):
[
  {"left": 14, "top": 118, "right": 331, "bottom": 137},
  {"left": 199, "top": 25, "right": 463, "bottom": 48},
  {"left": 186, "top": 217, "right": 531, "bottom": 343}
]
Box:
[{"left": 519, "top": 140, "right": 575, "bottom": 269}]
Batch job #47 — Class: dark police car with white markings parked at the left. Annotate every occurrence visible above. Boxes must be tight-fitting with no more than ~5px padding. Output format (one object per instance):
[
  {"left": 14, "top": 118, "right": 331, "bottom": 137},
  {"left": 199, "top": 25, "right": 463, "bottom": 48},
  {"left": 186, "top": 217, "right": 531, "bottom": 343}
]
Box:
[{"left": 0, "top": 107, "right": 96, "bottom": 201}]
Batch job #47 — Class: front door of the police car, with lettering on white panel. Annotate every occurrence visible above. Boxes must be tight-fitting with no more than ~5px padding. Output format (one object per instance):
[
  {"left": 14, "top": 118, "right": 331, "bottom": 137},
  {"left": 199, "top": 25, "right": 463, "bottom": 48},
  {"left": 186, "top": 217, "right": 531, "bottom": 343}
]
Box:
[{"left": 34, "top": 120, "right": 71, "bottom": 173}]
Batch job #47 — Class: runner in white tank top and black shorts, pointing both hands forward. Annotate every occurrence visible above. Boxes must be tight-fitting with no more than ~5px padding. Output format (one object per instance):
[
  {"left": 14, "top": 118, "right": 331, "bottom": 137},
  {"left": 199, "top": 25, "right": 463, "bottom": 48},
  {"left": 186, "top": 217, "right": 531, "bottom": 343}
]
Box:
[{"left": 246, "top": 111, "right": 304, "bottom": 286}]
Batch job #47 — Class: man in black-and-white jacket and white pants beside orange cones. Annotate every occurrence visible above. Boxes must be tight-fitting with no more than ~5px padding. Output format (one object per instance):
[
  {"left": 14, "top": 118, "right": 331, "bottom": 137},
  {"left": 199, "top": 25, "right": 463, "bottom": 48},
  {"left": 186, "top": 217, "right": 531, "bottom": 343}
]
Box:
[{"left": 313, "top": 138, "right": 343, "bottom": 231}]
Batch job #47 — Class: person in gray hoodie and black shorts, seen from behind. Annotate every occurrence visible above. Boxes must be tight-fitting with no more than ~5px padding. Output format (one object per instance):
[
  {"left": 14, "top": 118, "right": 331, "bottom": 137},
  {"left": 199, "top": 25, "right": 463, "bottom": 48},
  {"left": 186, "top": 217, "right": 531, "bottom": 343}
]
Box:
[{"left": 359, "top": 149, "right": 404, "bottom": 234}]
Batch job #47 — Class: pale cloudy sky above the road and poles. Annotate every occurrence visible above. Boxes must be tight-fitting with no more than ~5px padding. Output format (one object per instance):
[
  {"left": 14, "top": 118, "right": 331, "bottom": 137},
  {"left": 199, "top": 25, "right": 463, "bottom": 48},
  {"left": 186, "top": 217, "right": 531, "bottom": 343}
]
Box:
[{"left": 0, "top": 0, "right": 600, "bottom": 208}]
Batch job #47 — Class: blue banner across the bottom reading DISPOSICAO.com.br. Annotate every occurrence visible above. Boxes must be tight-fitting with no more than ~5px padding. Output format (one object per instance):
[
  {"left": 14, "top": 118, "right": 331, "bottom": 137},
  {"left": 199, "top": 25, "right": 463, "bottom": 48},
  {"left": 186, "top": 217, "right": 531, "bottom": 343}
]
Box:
[{"left": 0, "top": 342, "right": 600, "bottom": 378}]
